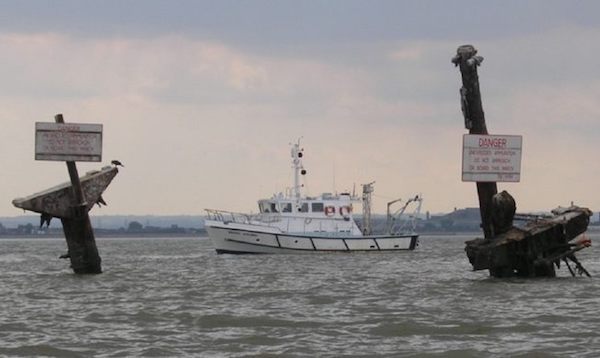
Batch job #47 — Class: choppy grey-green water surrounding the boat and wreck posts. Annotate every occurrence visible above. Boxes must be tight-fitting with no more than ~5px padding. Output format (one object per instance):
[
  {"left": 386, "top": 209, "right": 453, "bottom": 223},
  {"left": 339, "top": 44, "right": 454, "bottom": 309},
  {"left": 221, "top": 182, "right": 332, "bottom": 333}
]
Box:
[{"left": 0, "top": 235, "right": 600, "bottom": 357}]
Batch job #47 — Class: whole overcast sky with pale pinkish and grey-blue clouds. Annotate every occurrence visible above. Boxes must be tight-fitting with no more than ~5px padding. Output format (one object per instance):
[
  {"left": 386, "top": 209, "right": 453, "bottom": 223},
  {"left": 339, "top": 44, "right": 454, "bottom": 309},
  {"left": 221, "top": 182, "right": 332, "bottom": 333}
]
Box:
[{"left": 0, "top": 0, "right": 600, "bottom": 216}]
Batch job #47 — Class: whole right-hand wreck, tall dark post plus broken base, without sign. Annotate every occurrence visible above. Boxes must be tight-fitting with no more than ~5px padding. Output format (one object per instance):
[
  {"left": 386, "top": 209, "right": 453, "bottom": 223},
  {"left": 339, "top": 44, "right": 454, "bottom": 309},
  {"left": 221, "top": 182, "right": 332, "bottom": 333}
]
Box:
[{"left": 452, "top": 45, "right": 592, "bottom": 277}]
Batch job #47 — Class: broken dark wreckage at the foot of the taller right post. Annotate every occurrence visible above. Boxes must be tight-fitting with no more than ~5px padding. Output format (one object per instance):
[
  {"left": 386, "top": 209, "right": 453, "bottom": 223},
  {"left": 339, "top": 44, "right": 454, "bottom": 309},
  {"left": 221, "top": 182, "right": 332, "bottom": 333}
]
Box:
[{"left": 465, "top": 206, "right": 592, "bottom": 277}]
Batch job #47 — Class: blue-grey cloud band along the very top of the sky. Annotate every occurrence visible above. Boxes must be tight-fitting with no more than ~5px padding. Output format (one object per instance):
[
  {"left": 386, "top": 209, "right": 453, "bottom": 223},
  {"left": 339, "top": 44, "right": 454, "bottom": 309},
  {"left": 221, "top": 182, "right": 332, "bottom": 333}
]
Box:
[{"left": 0, "top": 0, "right": 600, "bottom": 51}]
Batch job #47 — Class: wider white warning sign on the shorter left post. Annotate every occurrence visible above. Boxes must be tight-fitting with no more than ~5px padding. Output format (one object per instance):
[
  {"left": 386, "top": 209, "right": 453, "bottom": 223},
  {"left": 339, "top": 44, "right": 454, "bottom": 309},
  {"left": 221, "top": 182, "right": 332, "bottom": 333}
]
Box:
[{"left": 35, "top": 122, "right": 102, "bottom": 162}]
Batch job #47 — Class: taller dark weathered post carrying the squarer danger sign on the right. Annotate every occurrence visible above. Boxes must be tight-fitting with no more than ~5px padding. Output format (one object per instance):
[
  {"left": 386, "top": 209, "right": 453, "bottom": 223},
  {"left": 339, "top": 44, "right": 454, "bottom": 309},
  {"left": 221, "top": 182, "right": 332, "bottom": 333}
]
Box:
[{"left": 452, "top": 45, "right": 498, "bottom": 239}]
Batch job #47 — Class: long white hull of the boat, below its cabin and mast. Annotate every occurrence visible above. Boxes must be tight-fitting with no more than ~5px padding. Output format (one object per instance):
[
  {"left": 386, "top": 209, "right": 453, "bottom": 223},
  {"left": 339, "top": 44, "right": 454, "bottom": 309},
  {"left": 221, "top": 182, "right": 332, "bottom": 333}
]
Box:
[{"left": 206, "top": 224, "right": 418, "bottom": 254}]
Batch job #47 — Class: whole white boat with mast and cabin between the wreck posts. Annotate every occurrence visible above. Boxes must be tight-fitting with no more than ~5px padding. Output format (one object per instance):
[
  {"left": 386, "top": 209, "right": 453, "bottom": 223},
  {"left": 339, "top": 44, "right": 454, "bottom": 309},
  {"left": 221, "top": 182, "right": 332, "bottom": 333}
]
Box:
[{"left": 204, "top": 141, "right": 422, "bottom": 254}]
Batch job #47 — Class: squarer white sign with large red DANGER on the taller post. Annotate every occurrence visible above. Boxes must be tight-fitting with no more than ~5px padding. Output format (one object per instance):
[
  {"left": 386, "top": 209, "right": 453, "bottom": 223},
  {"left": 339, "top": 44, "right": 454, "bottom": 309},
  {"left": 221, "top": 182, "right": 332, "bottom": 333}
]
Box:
[{"left": 462, "top": 134, "right": 523, "bottom": 182}]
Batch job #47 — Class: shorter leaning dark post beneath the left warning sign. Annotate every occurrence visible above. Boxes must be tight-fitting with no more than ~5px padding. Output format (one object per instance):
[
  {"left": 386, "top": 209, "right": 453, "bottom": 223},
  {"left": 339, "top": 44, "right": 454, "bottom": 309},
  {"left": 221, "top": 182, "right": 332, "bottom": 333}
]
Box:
[{"left": 54, "top": 114, "right": 102, "bottom": 274}]
